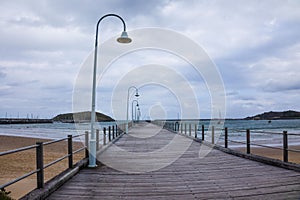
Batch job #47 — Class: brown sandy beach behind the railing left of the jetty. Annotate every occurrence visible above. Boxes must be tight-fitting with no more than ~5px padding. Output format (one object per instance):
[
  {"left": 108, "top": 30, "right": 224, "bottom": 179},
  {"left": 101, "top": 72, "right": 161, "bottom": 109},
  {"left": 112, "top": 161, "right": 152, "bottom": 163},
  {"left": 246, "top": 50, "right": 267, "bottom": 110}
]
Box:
[{"left": 0, "top": 136, "right": 84, "bottom": 199}]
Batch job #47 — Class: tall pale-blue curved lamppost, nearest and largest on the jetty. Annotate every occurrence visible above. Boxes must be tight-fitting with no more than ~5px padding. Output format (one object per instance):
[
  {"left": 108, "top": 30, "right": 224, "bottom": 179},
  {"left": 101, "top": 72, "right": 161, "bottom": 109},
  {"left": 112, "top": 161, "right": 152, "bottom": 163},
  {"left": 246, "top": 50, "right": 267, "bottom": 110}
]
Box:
[{"left": 88, "top": 14, "right": 132, "bottom": 167}]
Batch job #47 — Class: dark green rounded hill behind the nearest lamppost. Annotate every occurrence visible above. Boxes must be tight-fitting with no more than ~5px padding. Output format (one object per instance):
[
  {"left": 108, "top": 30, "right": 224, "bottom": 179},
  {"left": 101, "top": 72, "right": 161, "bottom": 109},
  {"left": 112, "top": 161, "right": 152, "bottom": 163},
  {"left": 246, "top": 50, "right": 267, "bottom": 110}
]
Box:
[{"left": 52, "top": 111, "right": 115, "bottom": 123}]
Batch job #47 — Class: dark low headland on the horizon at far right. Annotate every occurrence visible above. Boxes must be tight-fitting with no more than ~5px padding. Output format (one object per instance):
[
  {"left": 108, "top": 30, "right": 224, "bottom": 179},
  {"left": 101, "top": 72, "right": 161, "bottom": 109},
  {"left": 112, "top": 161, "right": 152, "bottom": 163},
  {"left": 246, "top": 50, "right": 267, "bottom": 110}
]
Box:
[{"left": 245, "top": 110, "right": 300, "bottom": 120}]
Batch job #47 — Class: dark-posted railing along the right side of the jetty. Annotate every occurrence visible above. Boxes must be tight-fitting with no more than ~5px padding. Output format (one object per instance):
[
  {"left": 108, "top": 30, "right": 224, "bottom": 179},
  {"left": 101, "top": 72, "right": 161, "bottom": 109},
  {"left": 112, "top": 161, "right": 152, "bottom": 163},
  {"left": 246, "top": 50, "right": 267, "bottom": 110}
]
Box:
[{"left": 162, "top": 120, "right": 300, "bottom": 162}]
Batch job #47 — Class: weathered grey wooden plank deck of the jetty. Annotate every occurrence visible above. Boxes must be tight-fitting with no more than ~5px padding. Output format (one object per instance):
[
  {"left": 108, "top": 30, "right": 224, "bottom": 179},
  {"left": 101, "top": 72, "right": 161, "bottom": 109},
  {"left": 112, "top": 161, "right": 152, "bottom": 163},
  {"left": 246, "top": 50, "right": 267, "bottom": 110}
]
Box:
[{"left": 48, "top": 124, "right": 300, "bottom": 200}]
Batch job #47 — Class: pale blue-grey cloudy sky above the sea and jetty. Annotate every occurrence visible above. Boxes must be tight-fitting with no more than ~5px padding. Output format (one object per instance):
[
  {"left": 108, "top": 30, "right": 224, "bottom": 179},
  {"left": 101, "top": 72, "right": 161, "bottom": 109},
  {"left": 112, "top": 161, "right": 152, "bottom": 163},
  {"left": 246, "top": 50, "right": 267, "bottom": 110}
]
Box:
[{"left": 0, "top": 0, "right": 300, "bottom": 118}]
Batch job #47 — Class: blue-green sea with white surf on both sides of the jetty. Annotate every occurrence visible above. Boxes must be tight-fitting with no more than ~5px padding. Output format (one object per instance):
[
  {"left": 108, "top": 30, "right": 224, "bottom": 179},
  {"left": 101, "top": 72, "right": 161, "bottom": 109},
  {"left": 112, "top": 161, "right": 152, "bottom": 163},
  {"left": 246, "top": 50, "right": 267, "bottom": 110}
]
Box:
[{"left": 0, "top": 120, "right": 300, "bottom": 147}]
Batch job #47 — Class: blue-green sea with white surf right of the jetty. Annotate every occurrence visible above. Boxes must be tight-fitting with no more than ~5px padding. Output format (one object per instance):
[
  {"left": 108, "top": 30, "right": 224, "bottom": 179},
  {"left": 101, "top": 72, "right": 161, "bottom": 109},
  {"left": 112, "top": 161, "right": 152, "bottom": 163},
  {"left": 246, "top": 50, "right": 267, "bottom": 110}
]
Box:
[{"left": 198, "top": 119, "right": 300, "bottom": 147}]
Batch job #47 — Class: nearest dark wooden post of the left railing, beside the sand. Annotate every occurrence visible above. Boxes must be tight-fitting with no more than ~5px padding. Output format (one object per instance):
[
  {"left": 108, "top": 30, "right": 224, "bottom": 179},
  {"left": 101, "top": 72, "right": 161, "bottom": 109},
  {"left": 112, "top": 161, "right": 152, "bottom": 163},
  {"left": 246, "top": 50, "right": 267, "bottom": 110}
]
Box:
[{"left": 36, "top": 142, "right": 44, "bottom": 188}]
